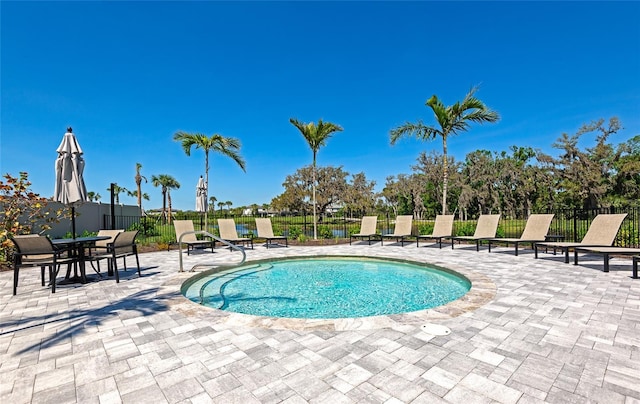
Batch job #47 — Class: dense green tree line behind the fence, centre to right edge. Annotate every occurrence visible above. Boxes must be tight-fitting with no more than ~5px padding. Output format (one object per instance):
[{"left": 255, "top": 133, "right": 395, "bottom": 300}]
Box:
[{"left": 271, "top": 117, "right": 640, "bottom": 219}]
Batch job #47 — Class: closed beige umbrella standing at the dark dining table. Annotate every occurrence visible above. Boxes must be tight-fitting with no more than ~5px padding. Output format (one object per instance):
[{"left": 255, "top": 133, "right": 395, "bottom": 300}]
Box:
[{"left": 53, "top": 128, "right": 87, "bottom": 238}]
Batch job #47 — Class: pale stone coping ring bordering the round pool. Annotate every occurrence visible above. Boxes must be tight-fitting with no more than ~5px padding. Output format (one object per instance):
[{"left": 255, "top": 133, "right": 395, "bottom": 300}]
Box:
[{"left": 158, "top": 253, "right": 497, "bottom": 331}]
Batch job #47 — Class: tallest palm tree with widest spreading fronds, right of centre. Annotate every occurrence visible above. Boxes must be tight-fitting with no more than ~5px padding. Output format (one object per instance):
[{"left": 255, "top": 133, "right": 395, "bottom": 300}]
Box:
[{"left": 390, "top": 86, "right": 500, "bottom": 215}]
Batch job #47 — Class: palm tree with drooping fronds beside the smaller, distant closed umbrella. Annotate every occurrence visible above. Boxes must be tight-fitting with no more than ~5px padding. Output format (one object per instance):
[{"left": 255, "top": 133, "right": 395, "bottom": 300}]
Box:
[{"left": 173, "top": 131, "right": 247, "bottom": 230}]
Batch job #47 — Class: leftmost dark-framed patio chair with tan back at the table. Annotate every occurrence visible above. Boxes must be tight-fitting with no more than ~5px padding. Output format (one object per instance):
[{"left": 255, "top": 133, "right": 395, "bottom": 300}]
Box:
[{"left": 11, "top": 234, "right": 76, "bottom": 296}]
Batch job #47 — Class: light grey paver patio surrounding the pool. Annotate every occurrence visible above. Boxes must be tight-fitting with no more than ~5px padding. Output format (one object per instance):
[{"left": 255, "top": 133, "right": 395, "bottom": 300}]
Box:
[{"left": 0, "top": 242, "right": 640, "bottom": 404}]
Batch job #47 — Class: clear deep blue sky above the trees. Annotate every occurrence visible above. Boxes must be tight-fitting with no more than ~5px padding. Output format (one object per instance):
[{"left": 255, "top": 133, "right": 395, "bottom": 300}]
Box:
[{"left": 0, "top": 1, "right": 640, "bottom": 209}]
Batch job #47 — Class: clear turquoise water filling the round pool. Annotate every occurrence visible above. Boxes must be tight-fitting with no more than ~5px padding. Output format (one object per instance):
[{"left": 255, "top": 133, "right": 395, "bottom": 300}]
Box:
[{"left": 183, "top": 258, "right": 471, "bottom": 319}]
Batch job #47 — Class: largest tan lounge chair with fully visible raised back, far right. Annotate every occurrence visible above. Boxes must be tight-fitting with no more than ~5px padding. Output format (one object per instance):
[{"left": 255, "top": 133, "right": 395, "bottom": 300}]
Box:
[{"left": 533, "top": 213, "right": 627, "bottom": 264}]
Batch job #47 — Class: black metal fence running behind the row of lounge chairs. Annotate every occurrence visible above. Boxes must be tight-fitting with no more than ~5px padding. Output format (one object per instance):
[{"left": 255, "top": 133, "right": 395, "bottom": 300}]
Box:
[{"left": 103, "top": 207, "right": 640, "bottom": 247}]
